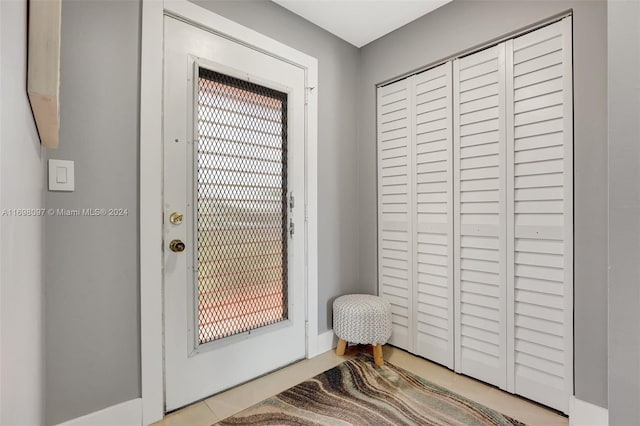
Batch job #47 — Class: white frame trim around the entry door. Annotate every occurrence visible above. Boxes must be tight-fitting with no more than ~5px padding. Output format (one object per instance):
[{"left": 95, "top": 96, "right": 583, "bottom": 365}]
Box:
[{"left": 139, "top": 0, "right": 323, "bottom": 425}]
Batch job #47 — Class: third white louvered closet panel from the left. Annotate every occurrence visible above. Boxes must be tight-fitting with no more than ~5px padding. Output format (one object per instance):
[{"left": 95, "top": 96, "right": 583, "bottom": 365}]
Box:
[{"left": 453, "top": 43, "right": 507, "bottom": 388}]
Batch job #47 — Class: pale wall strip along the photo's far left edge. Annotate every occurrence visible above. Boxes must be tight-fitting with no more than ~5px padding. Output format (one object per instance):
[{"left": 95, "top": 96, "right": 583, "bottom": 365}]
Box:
[{"left": 0, "top": 0, "right": 44, "bottom": 426}]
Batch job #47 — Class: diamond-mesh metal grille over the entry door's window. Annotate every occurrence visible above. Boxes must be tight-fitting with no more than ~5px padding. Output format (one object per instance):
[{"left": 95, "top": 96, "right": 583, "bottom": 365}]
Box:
[{"left": 194, "top": 68, "right": 288, "bottom": 344}]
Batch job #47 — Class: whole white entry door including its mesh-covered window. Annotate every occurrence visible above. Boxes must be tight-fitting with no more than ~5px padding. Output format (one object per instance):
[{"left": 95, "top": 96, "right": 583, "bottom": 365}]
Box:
[{"left": 163, "top": 17, "right": 306, "bottom": 411}]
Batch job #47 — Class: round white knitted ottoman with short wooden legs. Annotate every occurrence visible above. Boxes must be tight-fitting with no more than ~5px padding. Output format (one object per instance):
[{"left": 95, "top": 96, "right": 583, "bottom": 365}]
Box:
[{"left": 333, "top": 294, "right": 391, "bottom": 365}]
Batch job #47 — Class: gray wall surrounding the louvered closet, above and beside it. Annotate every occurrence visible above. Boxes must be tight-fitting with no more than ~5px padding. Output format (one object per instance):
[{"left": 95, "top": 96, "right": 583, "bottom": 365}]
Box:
[{"left": 358, "top": 0, "right": 607, "bottom": 407}]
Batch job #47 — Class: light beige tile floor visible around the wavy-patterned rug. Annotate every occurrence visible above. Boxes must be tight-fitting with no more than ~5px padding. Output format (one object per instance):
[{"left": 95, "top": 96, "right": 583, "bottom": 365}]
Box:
[{"left": 154, "top": 346, "right": 569, "bottom": 426}]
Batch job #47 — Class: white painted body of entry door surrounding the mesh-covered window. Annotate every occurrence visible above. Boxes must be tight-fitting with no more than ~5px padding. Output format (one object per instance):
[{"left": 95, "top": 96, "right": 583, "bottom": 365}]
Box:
[{"left": 163, "top": 17, "right": 306, "bottom": 411}]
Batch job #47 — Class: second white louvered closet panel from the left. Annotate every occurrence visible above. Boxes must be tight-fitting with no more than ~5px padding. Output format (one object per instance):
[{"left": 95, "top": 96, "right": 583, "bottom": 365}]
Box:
[{"left": 412, "top": 62, "right": 454, "bottom": 368}]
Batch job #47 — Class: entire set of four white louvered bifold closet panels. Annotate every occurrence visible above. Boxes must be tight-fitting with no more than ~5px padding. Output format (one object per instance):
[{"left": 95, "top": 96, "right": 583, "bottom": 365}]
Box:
[{"left": 378, "top": 17, "right": 573, "bottom": 412}]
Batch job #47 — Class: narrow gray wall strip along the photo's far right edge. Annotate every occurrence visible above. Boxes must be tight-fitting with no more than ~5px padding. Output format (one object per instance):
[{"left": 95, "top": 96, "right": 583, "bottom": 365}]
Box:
[{"left": 607, "top": 1, "right": 640, "bottom": 425}]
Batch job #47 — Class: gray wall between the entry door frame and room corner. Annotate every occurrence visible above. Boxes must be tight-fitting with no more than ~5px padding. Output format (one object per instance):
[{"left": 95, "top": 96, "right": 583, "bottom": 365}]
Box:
[{"left": 194, "top": 0, "right": 364, "bottom": 332}]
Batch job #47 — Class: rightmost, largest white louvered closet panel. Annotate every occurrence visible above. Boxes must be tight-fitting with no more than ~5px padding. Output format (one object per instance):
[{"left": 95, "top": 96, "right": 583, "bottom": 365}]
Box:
[{"left": 507, "top": 17, "right": 573, "bottom": 412}]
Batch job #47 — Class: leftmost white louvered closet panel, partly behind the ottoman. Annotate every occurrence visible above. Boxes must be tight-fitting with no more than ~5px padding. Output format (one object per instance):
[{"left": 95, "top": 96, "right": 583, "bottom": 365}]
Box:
[{"left": 377, "top": 79, "right": 414, "bottom": 350}]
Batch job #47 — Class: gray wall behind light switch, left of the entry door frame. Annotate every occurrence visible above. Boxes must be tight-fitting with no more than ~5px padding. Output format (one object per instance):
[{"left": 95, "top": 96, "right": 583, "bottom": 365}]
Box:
[{"left": 44, "top": 0, "right": 141, "bottom": 424}]
